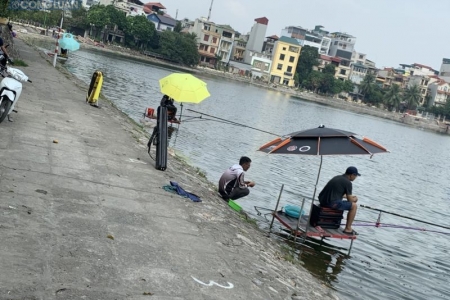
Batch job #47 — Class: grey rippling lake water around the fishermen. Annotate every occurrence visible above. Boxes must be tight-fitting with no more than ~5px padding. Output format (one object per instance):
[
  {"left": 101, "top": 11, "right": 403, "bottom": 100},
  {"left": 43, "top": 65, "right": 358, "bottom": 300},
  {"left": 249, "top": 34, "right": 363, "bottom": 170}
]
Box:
[{"left": 36, "top": 43, "right": 450, "bottom": 300}]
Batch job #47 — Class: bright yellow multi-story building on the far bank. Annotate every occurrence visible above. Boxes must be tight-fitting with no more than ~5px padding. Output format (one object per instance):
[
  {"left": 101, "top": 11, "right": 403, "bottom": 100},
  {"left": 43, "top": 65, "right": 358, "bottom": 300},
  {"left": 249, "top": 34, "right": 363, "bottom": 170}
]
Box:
[{"left": 270, "top": 36, "right": 302, "bottom": 87}]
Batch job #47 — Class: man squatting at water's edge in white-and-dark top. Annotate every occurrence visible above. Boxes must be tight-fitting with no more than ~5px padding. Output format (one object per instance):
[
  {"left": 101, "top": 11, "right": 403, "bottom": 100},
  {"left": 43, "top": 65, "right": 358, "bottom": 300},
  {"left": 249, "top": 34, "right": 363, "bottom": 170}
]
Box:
[{"left": 219, "top": 156, "right": 255, "bottom": 201}]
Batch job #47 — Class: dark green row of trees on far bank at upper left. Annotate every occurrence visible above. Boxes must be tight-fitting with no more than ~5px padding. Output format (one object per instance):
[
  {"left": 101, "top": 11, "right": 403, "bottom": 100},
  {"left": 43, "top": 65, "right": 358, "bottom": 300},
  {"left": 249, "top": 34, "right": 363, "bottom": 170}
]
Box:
[{"left": 8, "top": 5, "right": 200, "bottom": 66}]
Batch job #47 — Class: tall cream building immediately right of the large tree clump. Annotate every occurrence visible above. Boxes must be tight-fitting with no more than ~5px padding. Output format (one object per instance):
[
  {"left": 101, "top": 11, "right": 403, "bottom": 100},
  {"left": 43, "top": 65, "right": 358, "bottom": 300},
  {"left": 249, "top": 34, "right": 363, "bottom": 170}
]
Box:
[{"left": 189, "top": 18, "right": 221, "bottom": 67}]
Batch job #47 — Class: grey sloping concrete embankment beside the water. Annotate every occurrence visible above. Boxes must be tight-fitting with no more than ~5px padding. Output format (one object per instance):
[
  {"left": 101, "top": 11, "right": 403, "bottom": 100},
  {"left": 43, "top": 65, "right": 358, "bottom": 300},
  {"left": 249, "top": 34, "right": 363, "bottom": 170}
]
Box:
[{"left": 0, "top": 40, "right": 337, "bottom": 300}]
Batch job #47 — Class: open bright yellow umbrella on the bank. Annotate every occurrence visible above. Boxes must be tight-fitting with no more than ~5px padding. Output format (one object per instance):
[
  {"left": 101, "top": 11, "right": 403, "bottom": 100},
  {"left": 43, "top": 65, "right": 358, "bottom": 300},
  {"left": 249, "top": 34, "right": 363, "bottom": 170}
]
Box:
[{"left": 159, "top": 73, "right": 211, "bottom": 103}]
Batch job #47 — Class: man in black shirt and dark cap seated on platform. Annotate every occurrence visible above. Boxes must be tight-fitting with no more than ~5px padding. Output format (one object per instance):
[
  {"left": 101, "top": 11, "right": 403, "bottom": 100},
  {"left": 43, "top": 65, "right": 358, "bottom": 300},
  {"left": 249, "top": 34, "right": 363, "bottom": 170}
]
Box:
[{"left": 319, "top": 167, "right": 361, "bottom": 235}]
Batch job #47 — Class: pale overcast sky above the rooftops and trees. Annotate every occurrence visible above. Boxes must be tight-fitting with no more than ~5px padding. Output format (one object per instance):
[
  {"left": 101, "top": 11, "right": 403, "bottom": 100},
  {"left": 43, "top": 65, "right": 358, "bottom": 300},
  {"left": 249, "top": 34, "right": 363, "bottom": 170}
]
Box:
[{"left": 162, "top": 0, "right": 450, "bottom": 70}]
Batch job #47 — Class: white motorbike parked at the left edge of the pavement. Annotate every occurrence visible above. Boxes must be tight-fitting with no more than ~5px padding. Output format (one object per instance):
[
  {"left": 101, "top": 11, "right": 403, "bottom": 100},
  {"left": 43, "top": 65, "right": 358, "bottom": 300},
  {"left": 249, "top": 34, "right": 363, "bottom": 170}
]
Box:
[{"left": 0, "top": 55, "right": 31, "bottom": 123}]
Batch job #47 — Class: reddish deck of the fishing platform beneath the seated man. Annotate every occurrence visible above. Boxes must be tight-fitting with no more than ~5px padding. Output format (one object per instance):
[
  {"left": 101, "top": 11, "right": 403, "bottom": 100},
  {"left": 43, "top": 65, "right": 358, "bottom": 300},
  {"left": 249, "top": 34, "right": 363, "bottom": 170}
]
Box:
[{"left": 273, "top": 211, "right": 356, "bottom": 240}]
